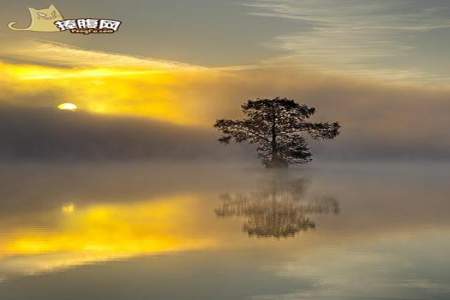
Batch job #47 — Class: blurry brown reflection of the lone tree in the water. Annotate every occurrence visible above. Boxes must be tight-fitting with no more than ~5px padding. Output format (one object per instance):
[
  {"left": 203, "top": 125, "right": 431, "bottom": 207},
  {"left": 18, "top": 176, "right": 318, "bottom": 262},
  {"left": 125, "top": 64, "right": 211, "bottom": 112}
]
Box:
[{"left": 215, "top": 177, "right": 339, "bottom": 238}]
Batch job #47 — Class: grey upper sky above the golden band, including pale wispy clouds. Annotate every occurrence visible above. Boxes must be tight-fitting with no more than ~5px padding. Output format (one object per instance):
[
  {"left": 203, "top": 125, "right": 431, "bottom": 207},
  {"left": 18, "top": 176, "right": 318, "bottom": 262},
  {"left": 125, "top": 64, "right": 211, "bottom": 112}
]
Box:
[{"left": 0, "top": 0, "right": 450, "bottom": 80}]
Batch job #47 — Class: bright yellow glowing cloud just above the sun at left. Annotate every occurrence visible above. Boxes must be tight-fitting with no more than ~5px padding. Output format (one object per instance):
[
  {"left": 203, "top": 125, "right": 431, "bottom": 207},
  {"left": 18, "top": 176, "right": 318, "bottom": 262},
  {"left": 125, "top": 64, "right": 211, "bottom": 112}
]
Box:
[{"left": 0, "top": 42, "right": 218, "bottom": 124}]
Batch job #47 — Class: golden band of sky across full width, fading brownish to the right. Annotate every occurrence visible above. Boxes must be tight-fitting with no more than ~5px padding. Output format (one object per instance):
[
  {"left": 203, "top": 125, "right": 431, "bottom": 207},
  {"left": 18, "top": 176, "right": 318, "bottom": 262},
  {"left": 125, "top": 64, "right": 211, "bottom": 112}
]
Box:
[{"left": 0, "top": 41, "right": 449, "bottom": 127}]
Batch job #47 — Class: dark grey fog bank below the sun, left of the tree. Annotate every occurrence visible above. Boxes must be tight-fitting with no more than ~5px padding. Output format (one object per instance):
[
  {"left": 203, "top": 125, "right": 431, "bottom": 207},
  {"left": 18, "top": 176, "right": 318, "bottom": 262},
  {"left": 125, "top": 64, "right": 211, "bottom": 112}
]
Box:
[{"left": 0, "top": 106, "right": 250, "bottom": 161}]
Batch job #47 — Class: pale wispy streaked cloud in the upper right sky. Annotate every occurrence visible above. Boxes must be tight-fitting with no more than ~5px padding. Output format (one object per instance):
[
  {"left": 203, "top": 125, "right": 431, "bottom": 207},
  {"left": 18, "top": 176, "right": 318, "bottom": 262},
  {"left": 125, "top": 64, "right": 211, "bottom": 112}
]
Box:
[{"left": 245, "top": 0, "right": 450, "bottom": 81}]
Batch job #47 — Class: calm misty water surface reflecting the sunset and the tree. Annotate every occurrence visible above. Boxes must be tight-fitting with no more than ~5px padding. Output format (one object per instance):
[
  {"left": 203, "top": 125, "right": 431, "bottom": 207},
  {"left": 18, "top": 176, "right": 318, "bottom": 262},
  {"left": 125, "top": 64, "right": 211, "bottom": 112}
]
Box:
[{"left": 0, "top": 163, "right": 450, "bottom": 300}]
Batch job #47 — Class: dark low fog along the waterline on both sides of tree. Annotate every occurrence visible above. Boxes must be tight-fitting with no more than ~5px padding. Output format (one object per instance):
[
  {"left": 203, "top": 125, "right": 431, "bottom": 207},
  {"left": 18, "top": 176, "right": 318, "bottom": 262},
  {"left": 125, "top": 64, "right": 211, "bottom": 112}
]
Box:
[{"left": 0, "top": 106, "right": 450, "bottom": 163}]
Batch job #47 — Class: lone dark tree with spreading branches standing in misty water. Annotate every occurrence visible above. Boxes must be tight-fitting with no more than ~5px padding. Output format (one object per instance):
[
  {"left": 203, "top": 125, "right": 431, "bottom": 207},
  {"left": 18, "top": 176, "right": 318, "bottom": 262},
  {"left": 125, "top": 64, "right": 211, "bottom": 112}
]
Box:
[{"left": 214, "top": 97, "right": 340, "bottom": 168}]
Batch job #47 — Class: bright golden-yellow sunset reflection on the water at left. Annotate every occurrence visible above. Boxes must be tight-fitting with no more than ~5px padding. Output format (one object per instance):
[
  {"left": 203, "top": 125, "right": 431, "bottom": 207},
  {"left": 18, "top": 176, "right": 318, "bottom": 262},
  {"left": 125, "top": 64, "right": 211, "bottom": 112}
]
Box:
[{"left": 0, "top": 197, "right": 217, "bottom": 273}]
